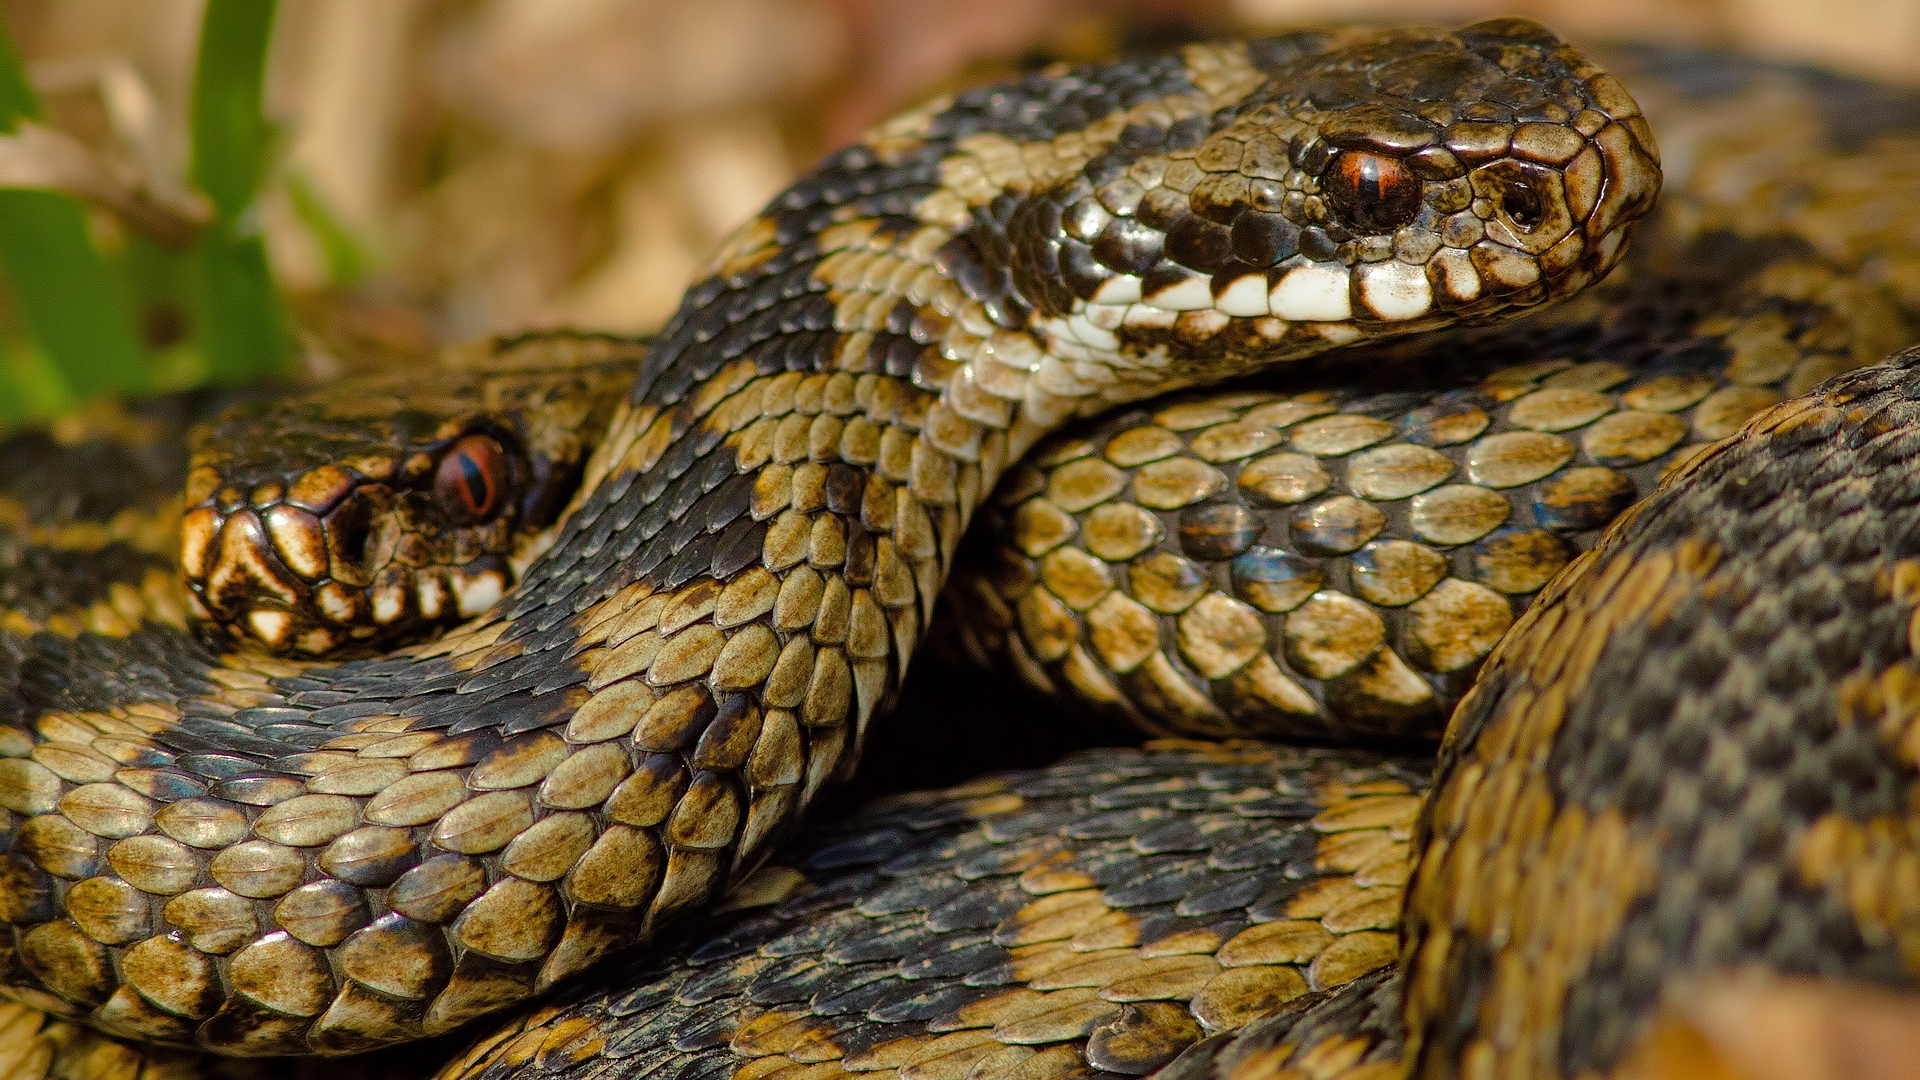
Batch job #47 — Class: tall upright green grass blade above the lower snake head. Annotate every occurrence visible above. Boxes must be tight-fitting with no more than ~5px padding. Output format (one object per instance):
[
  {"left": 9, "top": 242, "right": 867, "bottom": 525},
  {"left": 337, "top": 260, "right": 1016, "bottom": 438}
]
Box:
[{"left": 188, "top": 0, "right": 294, "bottom": 384}]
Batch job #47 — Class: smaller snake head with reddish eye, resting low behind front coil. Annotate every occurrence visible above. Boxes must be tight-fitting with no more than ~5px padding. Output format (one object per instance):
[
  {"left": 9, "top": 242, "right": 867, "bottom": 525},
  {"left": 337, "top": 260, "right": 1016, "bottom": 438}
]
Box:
[{"left": 180, "top": 336, "right": 643, "bottom": 655}]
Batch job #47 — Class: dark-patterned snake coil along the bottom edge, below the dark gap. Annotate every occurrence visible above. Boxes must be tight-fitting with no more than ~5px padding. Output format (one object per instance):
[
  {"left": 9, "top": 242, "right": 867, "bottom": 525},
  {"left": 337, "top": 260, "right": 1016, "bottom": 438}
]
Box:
[{"left": 420, "top": 744, "right": 1419, "bottom": 1080}]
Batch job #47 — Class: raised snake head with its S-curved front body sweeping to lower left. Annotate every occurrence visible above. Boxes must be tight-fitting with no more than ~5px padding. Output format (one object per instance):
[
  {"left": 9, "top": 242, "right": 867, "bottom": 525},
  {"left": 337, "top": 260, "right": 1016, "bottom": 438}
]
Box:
[{"left": 0, "top": 21, "right": 1659, "bottom": 1055}]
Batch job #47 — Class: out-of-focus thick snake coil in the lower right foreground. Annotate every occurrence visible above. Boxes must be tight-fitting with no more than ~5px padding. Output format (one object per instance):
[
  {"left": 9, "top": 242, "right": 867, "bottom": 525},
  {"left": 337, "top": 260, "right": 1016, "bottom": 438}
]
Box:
[{"left": 1405, "top": 350, "right": 1920, "bottom": 1076}]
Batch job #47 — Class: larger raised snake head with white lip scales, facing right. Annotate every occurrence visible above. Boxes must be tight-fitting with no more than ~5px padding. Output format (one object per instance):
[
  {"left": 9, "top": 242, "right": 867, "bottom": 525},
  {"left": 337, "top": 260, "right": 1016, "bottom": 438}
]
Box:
[{"left": 890, "top": 19, "right": 1661, "bottom": 407}]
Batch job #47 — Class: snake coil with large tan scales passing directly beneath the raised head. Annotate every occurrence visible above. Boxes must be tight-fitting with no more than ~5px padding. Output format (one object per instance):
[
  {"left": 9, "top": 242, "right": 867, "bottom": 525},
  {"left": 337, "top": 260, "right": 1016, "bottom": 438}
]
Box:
[{"left": 947, "top": 37, "right": 1920, "bottom": 740}]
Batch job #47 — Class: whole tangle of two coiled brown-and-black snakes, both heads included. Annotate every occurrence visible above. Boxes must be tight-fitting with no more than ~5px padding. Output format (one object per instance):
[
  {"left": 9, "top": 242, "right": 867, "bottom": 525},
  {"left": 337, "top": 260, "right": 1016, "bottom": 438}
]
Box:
[{"left": 0, "top": 21, "right": 1920, "bottom": 1080}]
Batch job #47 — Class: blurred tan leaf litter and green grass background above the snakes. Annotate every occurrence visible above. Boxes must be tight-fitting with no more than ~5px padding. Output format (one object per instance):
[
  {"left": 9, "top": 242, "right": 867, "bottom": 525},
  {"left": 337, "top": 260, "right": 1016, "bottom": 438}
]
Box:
[{"left": 0, "top": 0, "right": 1920, "bottom": 423}]
